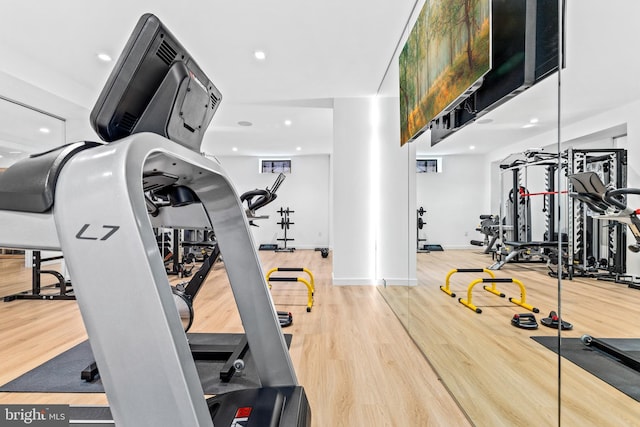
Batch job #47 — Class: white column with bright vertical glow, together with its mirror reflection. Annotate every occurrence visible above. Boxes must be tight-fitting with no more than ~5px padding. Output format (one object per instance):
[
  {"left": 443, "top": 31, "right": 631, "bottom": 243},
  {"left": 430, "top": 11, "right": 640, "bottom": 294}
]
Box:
[{"left": 332, "top": 97, "right": 415, "bottom": 285}]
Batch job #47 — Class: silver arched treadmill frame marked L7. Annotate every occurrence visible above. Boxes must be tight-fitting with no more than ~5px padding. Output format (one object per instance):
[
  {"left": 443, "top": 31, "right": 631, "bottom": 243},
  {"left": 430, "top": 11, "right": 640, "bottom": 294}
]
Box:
[{"left": 54, "top": 133, "right": 297, "bottom": 427}]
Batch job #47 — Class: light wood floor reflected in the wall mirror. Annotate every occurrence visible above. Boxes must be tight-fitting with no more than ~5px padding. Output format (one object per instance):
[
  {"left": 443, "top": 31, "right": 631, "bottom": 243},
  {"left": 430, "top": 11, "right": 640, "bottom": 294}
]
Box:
[{"left": 381, "top": 251, "right": 640, "bottom": 426}]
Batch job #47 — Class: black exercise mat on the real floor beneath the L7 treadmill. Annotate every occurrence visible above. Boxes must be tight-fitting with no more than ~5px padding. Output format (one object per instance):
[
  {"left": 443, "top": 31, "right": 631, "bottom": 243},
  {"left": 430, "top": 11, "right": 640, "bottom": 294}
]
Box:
[{"left": 0, "top": 334, "right": 291, "bottom": 394}]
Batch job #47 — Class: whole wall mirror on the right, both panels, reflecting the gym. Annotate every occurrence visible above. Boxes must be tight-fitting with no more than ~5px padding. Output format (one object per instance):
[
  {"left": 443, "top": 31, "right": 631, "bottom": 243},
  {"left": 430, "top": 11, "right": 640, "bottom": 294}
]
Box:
[{"left": 381, "top": 0, "right": 640, "bottom": 425}]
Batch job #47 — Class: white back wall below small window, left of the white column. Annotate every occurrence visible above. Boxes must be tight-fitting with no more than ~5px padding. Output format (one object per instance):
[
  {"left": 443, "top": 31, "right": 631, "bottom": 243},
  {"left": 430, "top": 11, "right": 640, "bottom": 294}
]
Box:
[{"left": 216, "top": 155, "right": 330, "bottom": 249}]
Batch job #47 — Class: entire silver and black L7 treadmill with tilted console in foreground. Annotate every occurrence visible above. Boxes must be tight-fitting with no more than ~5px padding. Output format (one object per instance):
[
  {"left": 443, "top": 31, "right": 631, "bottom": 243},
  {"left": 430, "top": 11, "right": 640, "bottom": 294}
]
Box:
[{"left": 0, "top": 14, "right": 311, "bottom": 427}]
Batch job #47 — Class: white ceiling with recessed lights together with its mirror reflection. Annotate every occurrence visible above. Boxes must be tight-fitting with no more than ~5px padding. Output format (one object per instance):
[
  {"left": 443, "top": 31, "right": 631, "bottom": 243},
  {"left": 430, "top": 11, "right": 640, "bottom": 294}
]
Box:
[{"left": 0, "top": 0, "right": 640, "bottom": 160}]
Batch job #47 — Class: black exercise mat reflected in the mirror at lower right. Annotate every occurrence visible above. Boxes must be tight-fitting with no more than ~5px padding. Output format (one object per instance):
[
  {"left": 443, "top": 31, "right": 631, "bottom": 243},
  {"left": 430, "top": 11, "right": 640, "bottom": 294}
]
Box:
[{"left": 531, "top": 336, "right": 640, "bottom": 402}]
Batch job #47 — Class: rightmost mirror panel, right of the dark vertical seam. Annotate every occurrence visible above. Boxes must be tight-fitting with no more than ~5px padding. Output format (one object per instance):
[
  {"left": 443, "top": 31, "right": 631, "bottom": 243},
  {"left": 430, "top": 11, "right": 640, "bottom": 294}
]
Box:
[{"left": 560, "top": 0, "right": 640, "bottom": 425}]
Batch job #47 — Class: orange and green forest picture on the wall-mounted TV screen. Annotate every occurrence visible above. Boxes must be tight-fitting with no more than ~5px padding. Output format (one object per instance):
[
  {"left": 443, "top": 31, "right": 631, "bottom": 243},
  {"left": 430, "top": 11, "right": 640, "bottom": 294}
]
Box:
[{"left": 399, "top": 0, "right": 491, "bottom": 145}]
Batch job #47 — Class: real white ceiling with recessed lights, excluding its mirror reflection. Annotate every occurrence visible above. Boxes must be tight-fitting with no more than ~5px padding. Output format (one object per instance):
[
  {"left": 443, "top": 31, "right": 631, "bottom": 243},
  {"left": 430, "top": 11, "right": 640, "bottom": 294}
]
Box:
[{"left": 0, "top": 0, "right": 414, "bottom": 155}]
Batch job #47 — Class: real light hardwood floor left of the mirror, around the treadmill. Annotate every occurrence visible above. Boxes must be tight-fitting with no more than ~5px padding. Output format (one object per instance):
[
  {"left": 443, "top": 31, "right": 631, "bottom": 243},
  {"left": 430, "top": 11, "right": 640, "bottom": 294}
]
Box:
[{"left": 0, "top": 251, "right": 470, "bottom": 427}]
